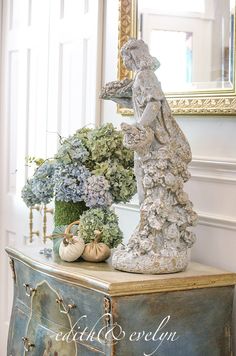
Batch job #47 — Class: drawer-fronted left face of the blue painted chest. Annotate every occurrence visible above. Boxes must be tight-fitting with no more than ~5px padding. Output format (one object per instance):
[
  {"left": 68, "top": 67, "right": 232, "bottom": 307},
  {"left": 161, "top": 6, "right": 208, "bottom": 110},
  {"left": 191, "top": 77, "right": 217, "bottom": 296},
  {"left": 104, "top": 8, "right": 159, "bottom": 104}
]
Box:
[{"left": 8, "top": 260, "right": 107, "bottom": 356}]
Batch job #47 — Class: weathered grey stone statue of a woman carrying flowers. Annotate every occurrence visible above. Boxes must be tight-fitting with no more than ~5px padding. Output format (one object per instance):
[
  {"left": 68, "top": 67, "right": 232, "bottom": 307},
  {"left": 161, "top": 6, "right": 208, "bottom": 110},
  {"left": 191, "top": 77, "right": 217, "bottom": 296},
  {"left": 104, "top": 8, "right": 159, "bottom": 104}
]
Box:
[{"left": 101, "top": 39, "right": 197, "bottom": 274}]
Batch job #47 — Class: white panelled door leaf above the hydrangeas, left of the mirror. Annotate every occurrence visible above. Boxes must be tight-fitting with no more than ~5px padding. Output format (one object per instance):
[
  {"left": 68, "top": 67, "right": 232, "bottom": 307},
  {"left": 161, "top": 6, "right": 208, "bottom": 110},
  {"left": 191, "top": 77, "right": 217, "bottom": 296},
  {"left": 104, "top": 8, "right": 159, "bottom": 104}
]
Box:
[{"left": 47, "top": 0, "right": 103, "bottom": 155}]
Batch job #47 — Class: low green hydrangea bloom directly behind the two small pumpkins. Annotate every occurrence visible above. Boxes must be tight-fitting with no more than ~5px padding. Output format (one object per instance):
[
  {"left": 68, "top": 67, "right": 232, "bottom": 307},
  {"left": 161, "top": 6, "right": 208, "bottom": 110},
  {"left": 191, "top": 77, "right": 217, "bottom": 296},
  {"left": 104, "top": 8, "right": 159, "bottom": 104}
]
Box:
[{"left": 79, "top": 208, "right": 123, "bottom": 248}]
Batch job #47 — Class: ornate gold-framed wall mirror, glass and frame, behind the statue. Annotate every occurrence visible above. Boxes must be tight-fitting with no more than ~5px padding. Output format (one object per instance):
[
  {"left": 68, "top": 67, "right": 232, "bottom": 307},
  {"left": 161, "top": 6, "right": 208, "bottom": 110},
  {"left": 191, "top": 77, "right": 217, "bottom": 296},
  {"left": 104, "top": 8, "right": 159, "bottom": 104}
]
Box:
[{"left": 118, "top": 0, "right": 236, "bottom": 115}]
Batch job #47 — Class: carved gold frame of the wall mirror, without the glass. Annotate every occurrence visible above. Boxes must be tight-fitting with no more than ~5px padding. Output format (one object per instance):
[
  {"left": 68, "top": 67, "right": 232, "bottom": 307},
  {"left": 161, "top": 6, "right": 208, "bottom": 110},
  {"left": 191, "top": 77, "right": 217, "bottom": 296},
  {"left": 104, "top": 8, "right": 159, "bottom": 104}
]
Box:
[{"left": 117, "top": 0, "right": 236, "bottom": 115}]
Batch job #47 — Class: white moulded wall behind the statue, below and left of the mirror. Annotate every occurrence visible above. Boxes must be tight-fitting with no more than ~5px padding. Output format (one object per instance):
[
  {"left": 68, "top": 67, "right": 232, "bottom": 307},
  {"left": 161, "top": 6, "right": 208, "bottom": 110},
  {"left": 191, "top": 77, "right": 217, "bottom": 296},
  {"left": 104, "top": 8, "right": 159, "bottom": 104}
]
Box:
[{"left": 102, "top": 0, "right": 236, "bottom": 345}]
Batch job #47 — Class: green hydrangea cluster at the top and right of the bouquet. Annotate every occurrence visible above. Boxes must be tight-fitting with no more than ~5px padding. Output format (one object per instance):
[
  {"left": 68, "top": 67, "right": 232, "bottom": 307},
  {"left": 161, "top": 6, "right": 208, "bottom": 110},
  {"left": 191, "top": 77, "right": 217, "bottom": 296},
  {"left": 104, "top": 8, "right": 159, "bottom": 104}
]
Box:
[{"left": 55, "top": 123, "right": 136, "bottom": 203}]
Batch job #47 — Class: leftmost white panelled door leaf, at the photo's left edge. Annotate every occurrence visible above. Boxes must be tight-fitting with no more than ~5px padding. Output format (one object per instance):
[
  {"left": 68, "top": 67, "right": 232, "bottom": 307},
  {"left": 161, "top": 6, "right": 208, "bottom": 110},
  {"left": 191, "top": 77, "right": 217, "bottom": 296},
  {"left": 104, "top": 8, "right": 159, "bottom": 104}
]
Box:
[{"left": 0, "top": 0, "right": 49, "bottom": 354}]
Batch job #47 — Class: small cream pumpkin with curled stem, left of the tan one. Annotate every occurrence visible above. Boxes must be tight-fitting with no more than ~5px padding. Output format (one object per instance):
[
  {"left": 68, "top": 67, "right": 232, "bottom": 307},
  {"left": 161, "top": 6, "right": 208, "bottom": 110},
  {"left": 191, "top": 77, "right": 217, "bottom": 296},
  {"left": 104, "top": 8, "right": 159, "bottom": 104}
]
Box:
[{"left": 59, "top": 221, "right": 85, "bottom": 262}]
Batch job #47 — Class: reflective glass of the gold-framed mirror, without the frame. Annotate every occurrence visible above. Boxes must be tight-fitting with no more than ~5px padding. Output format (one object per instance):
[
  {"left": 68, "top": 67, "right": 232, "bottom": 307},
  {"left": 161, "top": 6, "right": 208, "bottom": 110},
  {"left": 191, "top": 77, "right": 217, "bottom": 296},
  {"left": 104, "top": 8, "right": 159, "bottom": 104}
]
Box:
[{"left": 137, "top": 0, "right": 235, "bottom": 93}]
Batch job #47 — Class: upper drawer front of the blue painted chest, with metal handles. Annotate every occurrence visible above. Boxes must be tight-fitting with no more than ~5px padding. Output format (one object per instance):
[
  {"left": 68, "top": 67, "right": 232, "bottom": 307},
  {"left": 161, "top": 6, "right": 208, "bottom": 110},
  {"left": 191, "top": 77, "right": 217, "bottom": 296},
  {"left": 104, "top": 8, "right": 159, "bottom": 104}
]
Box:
[{"left": 15, "top": 261, "right": 110, "bottom": 352}]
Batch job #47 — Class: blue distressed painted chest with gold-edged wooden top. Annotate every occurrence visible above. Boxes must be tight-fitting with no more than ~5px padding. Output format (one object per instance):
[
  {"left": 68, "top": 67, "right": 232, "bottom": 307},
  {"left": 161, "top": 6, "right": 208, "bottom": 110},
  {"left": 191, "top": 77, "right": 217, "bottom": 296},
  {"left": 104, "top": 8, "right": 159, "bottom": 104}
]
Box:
[{"left": 7, "top": 249, "right": 236, "bottom": 356}]
